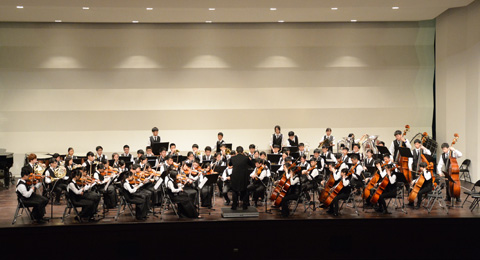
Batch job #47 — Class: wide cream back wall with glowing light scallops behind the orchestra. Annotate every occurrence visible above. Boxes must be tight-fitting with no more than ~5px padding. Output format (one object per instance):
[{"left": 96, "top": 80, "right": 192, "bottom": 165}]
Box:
[{"left": 0, "top": 21, "right": 435, "bottom": 175}]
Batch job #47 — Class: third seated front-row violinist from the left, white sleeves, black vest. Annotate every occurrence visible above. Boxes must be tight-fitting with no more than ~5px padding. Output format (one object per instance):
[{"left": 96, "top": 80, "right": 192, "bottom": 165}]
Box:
[{"left": 122, "top": 172, "right": 149, "bottom": 220}]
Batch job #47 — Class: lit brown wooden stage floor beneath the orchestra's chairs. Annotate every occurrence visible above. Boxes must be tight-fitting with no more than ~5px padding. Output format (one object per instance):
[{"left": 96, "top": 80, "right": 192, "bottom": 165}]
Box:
[{"left": 0, "top": 183, "right": 480, "bottom": 228}]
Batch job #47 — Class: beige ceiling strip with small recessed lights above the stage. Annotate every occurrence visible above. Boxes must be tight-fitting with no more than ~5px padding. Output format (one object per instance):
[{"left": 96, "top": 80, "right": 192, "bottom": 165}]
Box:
[{"left": 0, "top": 0, "right": 475, "bottom": 23}]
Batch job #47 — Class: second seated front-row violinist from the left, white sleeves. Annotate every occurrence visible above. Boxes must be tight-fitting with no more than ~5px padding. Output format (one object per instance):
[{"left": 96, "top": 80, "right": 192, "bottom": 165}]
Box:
[{"left": 67, "top": 170, "right": 98, "bottom": 221}]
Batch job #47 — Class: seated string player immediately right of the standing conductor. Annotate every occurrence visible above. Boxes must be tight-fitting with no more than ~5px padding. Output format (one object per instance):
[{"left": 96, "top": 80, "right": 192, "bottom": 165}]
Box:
[{"left": 247, "top": 159, "right": 270, "bottom": 207}]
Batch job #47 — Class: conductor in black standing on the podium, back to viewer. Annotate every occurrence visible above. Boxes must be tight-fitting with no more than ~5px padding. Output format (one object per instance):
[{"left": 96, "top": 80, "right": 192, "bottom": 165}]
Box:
[{"left": 230, "top": 146, "right": 253, "bottom": 210}]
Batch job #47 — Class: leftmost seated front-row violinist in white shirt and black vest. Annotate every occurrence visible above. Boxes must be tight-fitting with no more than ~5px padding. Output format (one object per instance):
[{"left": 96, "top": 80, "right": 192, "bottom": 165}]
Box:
[{"left": 16, "top": 160, "right": 48, "bottom": 224}]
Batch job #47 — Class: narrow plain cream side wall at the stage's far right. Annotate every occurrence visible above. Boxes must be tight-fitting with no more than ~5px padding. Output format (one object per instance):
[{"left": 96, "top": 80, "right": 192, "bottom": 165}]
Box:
[{"left": 436, "top": 1, "right": 480, "bottom": 181}]
